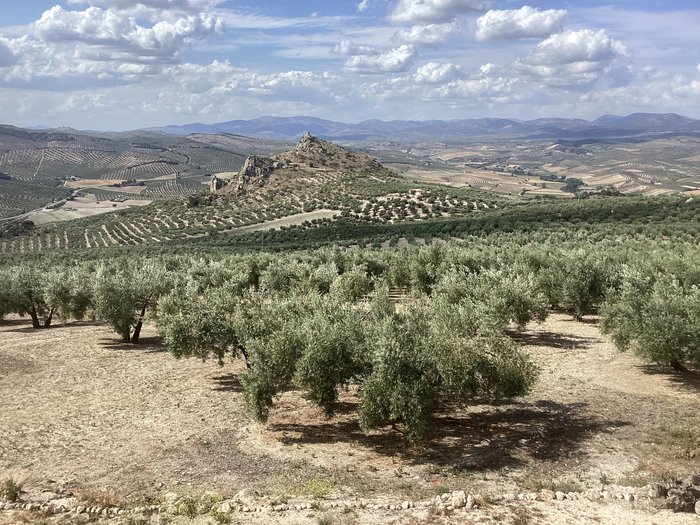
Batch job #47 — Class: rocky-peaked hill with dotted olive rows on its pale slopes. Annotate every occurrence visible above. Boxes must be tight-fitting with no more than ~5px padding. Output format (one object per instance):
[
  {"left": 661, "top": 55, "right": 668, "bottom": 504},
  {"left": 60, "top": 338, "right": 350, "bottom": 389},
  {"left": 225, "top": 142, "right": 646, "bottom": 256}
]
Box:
[{"left": 0, "top": 132, "right": 509, "bottom": 254}]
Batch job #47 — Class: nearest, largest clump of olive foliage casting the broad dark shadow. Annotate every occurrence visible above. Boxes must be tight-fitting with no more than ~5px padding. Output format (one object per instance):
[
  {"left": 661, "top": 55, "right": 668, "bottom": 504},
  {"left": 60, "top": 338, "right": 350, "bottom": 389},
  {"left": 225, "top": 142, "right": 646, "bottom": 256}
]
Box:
[{"left": 238, "top": 289, "right": 536, "bottom": 442}]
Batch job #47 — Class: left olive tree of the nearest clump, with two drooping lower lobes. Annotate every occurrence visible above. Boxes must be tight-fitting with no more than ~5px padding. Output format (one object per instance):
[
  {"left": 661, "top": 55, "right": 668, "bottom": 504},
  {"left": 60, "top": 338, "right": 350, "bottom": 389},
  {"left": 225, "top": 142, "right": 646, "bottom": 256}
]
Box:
[{"left": 240, "top": 297, "right": 366, "bottom": 421}]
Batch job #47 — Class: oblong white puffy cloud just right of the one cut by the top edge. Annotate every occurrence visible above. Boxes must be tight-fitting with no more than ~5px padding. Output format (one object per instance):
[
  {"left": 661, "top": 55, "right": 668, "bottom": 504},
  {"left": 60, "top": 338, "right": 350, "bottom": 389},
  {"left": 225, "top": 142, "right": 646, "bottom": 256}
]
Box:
[{"left": 476, "top": 6, "right": 566, "bottom": 41}]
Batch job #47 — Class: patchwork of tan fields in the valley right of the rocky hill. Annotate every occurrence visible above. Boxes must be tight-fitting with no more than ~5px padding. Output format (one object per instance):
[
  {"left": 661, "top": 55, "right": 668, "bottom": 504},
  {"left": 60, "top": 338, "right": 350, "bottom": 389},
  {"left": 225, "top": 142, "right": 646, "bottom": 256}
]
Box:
[{"left": 368, "top": 137, "right": 700, "bottom": 197}]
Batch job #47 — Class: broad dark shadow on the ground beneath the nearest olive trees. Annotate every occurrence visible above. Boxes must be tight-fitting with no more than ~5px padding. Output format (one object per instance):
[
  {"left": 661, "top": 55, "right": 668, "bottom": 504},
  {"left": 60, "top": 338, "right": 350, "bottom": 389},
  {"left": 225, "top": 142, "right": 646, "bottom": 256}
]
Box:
[{"left": 268, "top": 400, "right": 630, "bottom": 471}]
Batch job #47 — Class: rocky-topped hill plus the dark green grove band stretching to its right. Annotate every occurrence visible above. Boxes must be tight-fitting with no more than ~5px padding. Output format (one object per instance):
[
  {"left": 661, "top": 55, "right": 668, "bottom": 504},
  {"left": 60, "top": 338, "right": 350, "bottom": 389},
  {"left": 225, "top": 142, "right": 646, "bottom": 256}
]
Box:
[{"left": 0, "top": 130, "right": 700, "bottom": 257}]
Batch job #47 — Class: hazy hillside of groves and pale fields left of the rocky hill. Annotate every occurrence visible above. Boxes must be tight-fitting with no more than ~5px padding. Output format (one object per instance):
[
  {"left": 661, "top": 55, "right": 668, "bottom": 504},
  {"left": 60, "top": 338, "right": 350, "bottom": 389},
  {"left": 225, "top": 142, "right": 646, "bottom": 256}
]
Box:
[{"left": 0, "top": 126, "right": 283, "bottom": 219}]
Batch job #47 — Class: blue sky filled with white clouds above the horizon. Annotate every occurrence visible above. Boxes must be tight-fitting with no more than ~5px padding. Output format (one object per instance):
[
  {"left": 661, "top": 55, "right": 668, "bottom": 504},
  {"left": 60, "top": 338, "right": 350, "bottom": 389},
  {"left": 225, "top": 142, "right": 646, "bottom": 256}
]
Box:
[{"left": 0, "top": 0, "right": 700, "bottom": 130}]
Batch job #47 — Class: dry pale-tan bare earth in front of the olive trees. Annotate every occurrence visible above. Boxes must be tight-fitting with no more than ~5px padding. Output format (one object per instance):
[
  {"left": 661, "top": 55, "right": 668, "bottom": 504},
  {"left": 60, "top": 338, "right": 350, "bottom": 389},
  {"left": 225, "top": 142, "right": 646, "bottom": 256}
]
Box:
[{"left": 0, "top": 314, "right": 700, "bottom": 525}]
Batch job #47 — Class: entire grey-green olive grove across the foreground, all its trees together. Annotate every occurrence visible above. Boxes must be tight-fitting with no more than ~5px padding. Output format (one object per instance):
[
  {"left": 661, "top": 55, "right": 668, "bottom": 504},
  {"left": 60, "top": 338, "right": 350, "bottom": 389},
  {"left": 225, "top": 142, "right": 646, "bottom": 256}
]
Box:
[{"left": 0, "top": 244, "right": 700, "bottom": 441}]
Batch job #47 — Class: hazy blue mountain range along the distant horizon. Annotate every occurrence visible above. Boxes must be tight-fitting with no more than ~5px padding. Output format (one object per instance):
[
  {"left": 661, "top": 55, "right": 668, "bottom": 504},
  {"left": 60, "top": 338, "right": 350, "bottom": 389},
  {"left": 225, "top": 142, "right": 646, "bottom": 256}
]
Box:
[{"left": 141, "top": 113, "right": 700, "bottom": 142}]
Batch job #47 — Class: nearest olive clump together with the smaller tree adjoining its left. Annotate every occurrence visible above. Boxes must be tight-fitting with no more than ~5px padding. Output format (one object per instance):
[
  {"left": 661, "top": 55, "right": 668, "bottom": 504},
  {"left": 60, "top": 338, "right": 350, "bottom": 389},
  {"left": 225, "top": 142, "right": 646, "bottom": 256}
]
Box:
[{"left": 157, "top": 278, "right": 536, "bottom": 441}]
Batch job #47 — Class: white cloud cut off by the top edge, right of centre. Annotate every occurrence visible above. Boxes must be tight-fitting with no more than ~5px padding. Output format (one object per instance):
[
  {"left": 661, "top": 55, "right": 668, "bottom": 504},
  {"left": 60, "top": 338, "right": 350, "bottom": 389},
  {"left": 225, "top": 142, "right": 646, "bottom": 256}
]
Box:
[{"left": 389, "top": 0, "right": 489, "bottom": 24}]
